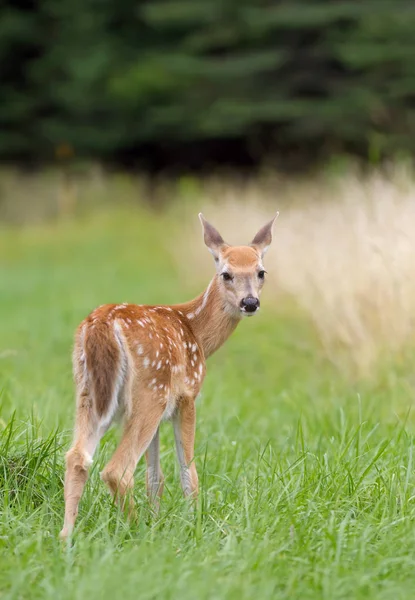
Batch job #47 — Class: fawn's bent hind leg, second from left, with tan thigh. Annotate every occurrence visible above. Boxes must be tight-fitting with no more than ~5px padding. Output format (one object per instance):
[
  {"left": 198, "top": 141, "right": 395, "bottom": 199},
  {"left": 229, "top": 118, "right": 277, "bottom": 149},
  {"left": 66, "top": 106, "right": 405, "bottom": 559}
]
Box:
[{"left": 101, "top": 392, "right": 164, "bottom": 518}]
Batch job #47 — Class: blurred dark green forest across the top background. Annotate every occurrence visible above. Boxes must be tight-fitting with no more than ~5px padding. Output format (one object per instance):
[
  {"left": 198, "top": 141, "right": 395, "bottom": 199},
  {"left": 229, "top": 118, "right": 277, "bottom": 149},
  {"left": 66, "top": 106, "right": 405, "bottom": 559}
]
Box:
[{"left": 0, "top": 0, "right": 415, "bottom": 166}]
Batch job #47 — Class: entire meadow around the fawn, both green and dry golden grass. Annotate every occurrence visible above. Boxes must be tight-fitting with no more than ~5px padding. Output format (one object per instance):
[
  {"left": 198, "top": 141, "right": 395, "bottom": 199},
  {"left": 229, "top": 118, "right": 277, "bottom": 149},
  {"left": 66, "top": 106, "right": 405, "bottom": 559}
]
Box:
[{"left": 0, "top": 173, "right": 415, "bottom": 600}]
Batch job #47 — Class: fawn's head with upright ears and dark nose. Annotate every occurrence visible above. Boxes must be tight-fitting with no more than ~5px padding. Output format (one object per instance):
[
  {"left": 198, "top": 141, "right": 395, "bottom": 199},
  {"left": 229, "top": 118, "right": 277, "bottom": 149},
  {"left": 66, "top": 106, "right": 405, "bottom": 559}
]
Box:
[{"left": 199, "top": 213, "right": 278, "bottom": 317}]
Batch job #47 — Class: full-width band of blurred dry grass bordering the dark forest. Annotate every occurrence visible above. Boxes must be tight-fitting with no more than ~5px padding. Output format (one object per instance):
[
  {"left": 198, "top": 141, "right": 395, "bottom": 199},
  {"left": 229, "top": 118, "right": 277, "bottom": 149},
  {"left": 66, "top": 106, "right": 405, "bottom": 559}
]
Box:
[{"left": 0, "top": 166, "right": 415, "bottom": 374}]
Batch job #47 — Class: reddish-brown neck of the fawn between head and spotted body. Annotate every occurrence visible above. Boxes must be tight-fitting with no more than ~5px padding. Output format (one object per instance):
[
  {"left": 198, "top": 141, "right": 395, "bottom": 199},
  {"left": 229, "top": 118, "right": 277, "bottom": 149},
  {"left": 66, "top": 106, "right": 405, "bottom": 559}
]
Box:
[{"left": 175, "top": 275, "right": 240, "bottom": 358}]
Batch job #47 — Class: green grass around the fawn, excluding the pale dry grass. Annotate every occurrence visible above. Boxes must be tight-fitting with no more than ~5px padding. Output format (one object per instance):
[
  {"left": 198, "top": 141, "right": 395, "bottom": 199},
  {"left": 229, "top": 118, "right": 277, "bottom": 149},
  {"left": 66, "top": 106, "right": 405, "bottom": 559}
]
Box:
[{"left": 0, "top": 207, "right": 415, "bottom": 600}]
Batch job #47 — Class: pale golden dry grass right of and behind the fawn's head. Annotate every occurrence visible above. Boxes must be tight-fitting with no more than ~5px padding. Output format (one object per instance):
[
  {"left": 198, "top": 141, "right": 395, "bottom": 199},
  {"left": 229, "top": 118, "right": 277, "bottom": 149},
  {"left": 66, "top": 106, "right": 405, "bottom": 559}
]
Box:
[{"left": 170, "top": 167, "right": 415, "bottom": 375}]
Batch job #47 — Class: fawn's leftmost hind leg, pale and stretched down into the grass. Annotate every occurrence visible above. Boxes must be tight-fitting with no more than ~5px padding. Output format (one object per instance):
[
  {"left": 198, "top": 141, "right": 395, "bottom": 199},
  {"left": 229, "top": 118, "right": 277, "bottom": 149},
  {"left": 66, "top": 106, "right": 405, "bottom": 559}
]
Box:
[{"left": 60, "top": 392, "right": 105, "bottom": 539}]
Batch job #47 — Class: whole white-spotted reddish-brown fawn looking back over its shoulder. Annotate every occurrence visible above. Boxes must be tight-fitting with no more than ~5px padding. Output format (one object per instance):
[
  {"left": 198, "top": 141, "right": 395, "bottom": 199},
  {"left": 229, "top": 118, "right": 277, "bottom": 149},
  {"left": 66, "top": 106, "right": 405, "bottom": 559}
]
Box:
[{"left": 60, "top": 213, "right": 278, "bottom": 539}]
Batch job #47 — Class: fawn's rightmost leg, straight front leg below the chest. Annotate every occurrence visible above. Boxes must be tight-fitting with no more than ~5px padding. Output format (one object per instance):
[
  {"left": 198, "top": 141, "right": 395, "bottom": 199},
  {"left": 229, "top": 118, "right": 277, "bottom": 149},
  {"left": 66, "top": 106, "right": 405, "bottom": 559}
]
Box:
[{"left": 173, "top": 397, "right": 198, "bottom": 498}]
